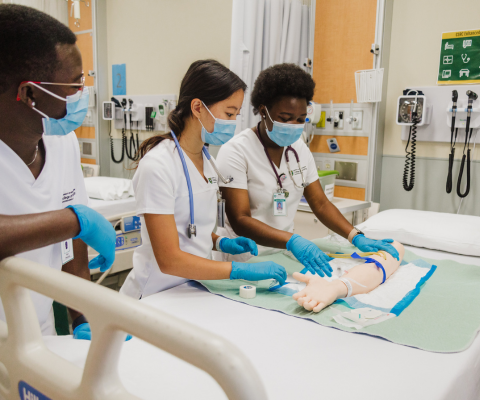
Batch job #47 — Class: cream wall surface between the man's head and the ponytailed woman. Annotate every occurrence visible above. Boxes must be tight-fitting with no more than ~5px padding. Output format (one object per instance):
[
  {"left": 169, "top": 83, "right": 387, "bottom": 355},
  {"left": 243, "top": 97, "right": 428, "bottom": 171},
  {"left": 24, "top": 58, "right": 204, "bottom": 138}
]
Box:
[{"left": 107, "top": 0, "right": 232, "bottom": 140}]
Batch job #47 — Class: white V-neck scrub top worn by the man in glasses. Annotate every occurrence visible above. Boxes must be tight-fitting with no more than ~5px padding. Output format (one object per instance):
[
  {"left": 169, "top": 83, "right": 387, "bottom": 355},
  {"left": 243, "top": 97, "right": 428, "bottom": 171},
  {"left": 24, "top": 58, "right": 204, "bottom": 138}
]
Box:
[{"left": 0, "top": 132, "right": 88, "bottom": 335}]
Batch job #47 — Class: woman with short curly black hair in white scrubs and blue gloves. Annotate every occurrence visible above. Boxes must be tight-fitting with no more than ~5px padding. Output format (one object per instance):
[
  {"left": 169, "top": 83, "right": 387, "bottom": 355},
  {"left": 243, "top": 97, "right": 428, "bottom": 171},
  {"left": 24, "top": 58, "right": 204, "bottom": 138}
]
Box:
[{"left": 215, "top": 64, "right": 398, "bottom": 276}]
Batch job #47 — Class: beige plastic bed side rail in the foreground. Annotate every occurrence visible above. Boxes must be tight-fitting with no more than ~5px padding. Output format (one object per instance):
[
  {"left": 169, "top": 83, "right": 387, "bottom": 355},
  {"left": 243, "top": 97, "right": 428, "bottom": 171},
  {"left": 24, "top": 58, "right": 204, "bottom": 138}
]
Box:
[{"left": 0, "top": 257, "right": 267, "bottom": 400}]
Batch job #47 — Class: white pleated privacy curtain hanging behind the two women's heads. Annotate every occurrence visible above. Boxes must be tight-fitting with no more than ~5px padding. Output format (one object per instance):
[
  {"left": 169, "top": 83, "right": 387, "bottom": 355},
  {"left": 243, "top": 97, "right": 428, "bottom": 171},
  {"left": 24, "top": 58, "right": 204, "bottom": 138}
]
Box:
[{"left": 230, "top": 0, "right": 310, "bottom": 131}]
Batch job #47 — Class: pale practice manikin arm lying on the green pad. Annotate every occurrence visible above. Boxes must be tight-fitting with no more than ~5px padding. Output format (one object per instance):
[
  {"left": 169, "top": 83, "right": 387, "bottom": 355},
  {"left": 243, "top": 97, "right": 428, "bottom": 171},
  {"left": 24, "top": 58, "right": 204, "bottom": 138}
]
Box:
[{"left": 293, "top": 241, "right": 405, "bottom": 312}]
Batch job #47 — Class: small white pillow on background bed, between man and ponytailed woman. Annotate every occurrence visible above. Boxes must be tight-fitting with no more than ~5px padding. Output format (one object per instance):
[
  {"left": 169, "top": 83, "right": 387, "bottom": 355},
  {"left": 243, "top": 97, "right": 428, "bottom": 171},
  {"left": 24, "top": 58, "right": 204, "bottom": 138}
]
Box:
[{"left": 85, "top": 176, "right": 134, "bottom": 200}]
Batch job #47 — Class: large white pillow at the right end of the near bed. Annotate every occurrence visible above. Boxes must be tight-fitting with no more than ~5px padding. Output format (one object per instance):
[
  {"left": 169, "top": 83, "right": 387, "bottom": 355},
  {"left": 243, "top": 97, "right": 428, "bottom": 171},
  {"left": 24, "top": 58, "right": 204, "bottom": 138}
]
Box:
[{"left": 357, "top": 210, "right": 480, "bottom": 257}]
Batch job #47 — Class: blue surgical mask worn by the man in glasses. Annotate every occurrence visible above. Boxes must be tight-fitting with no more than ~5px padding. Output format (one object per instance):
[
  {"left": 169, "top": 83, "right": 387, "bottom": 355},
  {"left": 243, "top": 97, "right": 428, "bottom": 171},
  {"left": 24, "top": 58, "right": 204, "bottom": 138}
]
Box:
[{"left": 31, "top": 82, "right": 89, "bottom": 136}]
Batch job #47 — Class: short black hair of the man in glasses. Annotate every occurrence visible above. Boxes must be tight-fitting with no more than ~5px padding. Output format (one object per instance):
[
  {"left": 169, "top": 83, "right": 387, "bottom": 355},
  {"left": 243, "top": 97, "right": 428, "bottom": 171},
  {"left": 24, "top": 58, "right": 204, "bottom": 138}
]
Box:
[{"left": 0, "top": 4, "right": 77, "bottom": 94}]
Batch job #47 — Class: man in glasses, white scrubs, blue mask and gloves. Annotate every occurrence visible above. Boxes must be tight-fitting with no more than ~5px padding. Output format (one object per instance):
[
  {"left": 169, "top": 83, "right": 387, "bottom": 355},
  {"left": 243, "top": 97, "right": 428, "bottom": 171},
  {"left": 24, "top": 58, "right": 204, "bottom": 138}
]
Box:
[{"left": 0, "top": 5, "right": 115, "bottom": 338}]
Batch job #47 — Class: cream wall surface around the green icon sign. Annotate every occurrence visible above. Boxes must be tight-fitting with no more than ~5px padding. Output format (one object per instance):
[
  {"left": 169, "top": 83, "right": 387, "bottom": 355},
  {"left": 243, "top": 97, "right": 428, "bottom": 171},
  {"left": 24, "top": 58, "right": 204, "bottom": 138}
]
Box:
[{"left": 383, "top": 0, "right": 480, "bottom": 159}]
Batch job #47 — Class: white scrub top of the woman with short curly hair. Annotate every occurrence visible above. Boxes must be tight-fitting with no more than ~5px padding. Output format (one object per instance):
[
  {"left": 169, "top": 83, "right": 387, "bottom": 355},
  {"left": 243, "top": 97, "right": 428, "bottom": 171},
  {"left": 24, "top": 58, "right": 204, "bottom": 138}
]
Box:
[{"left": 214, "top": 129, "right": 318, "bottom": 261}]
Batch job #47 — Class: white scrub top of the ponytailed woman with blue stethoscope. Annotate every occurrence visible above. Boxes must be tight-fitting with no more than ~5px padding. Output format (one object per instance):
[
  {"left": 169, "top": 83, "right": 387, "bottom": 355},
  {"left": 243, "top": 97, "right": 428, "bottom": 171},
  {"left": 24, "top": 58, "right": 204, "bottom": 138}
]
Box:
[{"left": 120, "top": 139, "right": 218, "bottom": 299}]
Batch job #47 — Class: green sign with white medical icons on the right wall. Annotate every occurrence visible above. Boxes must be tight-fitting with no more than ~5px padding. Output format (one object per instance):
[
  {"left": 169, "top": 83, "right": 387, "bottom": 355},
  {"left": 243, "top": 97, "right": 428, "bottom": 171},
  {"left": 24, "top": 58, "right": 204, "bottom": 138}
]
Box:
[{"left": 437, "top": 29, "right": 480, "bottom": 85}]
